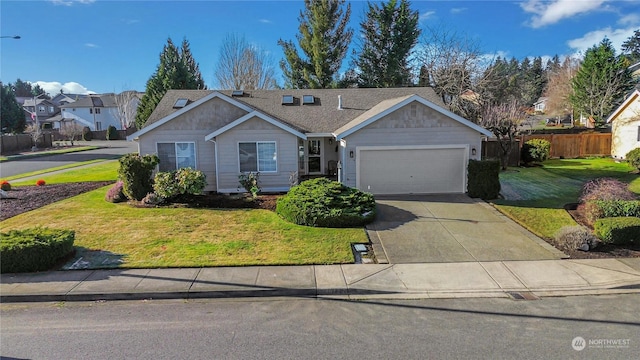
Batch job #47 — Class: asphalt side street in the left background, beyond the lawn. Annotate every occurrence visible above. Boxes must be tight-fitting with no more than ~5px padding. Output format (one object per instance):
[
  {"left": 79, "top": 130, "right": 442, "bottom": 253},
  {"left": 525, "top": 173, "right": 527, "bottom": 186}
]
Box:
[{"left": 0, "top": 141, "right": 138, "bottom": 177}]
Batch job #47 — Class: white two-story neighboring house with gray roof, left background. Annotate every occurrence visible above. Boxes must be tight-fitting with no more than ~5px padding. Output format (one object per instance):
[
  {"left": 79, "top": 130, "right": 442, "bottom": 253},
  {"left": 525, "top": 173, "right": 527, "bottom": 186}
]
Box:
[{"left": 60, "top": 94, "right": 124, "bottom": 131}]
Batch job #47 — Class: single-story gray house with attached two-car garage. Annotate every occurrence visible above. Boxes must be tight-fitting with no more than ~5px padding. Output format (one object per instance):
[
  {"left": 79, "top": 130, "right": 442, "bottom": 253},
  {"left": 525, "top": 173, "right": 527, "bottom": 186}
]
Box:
[{"left": 127, "top": 87, "right": 492, "bottom": 194}]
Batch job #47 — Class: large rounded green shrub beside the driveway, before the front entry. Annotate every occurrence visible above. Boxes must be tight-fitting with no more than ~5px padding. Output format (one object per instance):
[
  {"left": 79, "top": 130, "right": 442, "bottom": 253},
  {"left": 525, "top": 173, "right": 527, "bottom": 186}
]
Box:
[{"left": 276, "top": 178, "right": 376, "bottom": 228}]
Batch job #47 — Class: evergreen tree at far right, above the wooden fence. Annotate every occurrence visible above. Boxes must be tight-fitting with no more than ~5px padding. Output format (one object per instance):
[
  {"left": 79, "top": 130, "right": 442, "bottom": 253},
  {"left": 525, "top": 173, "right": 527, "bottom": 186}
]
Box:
[{"left": 570, "top": 38, "right": 633, "bottom": 124}]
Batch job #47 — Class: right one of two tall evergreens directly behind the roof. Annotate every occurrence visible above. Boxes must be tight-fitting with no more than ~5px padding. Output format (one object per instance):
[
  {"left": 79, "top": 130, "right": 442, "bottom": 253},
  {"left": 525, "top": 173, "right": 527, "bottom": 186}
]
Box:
[{"left": 354, "top": 0, "right": 420, "bottom": 87}]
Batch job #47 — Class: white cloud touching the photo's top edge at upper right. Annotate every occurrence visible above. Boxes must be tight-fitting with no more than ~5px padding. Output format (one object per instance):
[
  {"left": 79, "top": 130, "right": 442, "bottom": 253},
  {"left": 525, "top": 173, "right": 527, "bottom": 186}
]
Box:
[{"left": 520, "top": 0, "right": 607, "bottom": 28}]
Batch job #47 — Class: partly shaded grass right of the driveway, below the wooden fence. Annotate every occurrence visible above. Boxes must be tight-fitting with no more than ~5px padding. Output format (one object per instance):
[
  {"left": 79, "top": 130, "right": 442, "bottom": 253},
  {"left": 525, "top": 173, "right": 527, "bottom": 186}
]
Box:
[{"left": 494, "top": 158, "right": 640, "bottom": 238}]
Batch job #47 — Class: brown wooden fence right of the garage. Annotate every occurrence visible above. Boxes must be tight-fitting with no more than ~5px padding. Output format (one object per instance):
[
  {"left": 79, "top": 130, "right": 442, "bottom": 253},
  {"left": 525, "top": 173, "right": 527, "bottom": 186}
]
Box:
[{"left": 482, "top": 133, "right": 611, "bottom": 166}]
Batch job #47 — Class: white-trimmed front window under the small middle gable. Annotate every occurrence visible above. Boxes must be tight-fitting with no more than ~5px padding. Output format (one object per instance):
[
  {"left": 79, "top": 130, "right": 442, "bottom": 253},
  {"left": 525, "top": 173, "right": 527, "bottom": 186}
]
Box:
[{"left": 238, "top": 141, "right": 278, "bottom": 172}]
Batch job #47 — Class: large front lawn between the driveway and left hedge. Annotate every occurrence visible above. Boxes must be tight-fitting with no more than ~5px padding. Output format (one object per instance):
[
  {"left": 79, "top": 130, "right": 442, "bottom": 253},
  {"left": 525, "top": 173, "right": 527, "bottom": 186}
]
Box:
[{"left": 0, "top": 187, "right": 368, "bottom": 268}]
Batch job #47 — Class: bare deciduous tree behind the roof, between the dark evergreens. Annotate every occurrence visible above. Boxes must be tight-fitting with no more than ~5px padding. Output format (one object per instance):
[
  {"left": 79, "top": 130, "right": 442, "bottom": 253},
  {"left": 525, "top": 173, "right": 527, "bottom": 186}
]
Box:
[{"left": 215, "top": 34, "right": 277, "bottom": 90}]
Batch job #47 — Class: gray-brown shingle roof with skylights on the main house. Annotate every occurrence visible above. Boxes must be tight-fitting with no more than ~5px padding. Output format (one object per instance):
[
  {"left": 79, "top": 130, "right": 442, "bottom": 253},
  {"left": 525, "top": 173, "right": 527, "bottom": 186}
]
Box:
[{"left": 145, "top": 87, "right": 445, "bottom": 133}]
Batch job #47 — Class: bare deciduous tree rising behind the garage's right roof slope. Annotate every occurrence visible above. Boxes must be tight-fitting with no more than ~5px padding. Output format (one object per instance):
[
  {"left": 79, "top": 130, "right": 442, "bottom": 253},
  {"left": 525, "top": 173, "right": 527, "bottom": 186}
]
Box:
[{"left": 418, "top": 25, "right": 487, "bottom": 121}]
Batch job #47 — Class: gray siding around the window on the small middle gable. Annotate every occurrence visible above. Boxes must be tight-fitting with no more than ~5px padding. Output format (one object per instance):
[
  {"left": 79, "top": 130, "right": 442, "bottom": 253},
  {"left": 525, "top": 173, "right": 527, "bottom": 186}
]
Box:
[{"left": 215, "top": 118, "right": 298, "bottom": 193}]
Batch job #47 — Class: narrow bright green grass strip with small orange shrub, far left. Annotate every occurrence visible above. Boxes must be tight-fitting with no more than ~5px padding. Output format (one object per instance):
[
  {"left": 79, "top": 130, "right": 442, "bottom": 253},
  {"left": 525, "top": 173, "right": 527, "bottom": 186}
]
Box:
[{"left": 11, "top": 160, "right": 119, "bottom": 186}]
